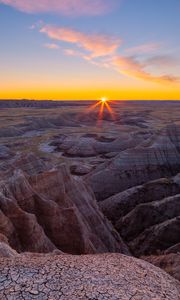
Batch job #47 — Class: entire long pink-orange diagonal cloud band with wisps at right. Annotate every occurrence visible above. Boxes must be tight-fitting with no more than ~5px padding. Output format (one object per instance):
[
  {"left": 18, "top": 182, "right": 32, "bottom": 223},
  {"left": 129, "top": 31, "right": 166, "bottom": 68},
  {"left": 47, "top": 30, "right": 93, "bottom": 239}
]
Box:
[{"left": 40, "top": 25, "right": 179, "bottom": 83}]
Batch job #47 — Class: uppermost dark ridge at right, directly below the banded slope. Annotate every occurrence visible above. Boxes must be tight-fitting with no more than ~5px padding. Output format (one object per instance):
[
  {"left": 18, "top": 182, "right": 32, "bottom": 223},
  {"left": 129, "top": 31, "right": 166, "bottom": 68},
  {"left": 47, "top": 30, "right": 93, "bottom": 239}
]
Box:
[{"left": 99, "top": 177, "right": 180, "bottom": 224}]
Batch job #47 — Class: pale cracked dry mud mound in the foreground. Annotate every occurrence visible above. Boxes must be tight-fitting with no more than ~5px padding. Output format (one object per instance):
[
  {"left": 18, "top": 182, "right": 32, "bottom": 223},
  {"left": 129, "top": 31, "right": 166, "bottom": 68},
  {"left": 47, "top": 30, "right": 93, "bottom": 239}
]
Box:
[{"left": 0, "top": 254, "right": 180, "bottom": 300}]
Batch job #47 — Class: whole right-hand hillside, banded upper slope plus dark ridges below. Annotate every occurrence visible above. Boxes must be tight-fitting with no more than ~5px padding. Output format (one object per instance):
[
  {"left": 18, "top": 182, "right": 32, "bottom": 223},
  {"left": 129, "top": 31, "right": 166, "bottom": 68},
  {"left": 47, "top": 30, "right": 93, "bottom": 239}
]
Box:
[{"left": 92, "top": 125, "right": 180, "bottom": 256}]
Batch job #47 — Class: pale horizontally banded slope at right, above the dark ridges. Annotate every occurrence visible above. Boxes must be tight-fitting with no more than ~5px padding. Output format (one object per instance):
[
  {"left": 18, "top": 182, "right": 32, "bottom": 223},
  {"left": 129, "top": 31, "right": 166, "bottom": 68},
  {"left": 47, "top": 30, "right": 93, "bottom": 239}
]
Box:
[{"left": 87, "top": 126, "right": 180, "bottom": 201}]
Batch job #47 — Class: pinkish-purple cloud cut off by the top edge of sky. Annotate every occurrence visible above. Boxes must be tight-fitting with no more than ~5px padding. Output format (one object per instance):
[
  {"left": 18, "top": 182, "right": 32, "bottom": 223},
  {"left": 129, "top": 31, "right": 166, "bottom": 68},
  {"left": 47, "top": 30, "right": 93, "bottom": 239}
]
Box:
[{"left": 0, "top": 0, "right": 118, "bottom": 16}]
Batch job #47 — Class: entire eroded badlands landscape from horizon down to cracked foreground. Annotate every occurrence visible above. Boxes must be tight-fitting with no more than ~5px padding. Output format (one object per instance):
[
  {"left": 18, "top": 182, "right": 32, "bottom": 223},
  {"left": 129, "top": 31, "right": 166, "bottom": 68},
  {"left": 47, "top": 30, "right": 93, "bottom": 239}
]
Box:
[{"left": 0, "top": 100, "right": 180, "bottom": 300}]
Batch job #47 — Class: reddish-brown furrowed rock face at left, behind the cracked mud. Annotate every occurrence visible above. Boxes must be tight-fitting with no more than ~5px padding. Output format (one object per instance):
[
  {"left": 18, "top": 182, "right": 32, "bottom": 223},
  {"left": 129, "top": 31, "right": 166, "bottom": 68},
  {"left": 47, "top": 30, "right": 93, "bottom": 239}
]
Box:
[{"left": 0, "top": 155, "right": 129, "bottom": 254}]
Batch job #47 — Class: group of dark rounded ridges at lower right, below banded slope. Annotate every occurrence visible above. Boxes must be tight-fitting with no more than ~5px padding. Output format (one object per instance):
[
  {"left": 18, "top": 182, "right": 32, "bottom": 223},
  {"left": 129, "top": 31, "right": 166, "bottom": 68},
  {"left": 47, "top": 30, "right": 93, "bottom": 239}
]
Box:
[{"left": 99, "top": 175, "right": 180, "bottom": 256}]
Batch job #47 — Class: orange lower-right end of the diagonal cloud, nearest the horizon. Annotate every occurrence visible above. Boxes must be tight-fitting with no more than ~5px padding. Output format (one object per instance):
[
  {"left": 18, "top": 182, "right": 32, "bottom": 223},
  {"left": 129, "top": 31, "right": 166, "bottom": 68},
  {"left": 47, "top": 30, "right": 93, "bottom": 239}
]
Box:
[{"left": 112, "top": 56, "right": 179, "bottom": 83}]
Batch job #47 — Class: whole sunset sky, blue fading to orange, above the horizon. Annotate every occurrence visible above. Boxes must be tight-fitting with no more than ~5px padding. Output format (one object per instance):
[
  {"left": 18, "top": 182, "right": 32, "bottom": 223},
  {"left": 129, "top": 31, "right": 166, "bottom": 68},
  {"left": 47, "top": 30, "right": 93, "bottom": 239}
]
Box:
[{"left": 0, "top": 0, "right": 180, "bottom": 100}]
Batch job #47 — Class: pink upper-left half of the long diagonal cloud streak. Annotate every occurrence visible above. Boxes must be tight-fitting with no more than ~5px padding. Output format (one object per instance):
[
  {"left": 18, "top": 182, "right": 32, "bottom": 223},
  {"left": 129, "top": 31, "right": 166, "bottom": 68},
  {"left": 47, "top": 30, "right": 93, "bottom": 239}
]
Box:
[{"left": 40, "top": 25, "right": 120, "bottom": 58}]
